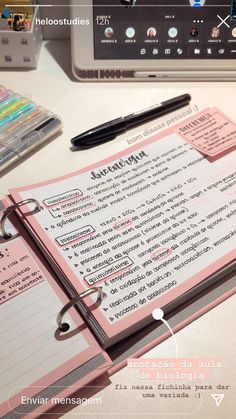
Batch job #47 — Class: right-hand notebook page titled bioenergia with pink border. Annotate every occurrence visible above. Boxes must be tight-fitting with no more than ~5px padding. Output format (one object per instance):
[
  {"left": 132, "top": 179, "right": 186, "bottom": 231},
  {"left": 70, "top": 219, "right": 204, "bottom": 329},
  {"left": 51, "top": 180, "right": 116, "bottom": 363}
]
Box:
[{"left": 2, "top": 106, "right": 236, "bottom": 348}]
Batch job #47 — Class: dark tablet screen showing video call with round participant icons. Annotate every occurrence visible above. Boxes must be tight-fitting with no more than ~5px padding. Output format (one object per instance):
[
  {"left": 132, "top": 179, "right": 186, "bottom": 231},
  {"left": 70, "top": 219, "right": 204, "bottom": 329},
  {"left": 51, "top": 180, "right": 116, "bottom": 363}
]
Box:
[{"left": 93, "top": 0, "right": 236, "bottom": 60}]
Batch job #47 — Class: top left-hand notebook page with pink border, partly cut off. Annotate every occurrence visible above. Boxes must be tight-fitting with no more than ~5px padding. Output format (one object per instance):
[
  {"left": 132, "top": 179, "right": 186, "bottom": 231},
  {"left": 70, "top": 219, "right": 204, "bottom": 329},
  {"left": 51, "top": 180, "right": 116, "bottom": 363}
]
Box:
[{"left": 0, "top": 212, "right": 105, "bottom": 413}]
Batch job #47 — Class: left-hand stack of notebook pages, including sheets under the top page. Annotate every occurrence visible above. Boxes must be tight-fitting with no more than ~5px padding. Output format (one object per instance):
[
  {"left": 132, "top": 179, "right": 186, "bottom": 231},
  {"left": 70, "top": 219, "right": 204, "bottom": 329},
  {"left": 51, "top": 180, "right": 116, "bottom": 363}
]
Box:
[{"left": 0, "top": 201, "right": 112, "bottom": 419}]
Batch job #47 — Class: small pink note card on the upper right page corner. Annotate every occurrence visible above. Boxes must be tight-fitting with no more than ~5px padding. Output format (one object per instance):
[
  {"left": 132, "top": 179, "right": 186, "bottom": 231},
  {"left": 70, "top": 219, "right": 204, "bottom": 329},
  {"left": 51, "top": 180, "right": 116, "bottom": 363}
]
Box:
[{"left": 174, "top": 108, "right": 236, "bottom": 157}]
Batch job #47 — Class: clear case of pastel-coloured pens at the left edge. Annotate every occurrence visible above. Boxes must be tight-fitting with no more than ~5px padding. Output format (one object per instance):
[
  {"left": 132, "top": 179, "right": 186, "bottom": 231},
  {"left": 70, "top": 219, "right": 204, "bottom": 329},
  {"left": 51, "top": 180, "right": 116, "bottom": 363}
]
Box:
[{"left": 0, "top": 86, "right": 62, "bottom": 172}]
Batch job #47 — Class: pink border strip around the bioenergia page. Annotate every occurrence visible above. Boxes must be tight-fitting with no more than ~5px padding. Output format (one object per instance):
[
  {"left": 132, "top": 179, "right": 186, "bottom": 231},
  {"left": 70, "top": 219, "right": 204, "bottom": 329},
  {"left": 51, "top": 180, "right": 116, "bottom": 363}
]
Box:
[{"left": 11, "top": 126, "right": 236, "bottom": 346}]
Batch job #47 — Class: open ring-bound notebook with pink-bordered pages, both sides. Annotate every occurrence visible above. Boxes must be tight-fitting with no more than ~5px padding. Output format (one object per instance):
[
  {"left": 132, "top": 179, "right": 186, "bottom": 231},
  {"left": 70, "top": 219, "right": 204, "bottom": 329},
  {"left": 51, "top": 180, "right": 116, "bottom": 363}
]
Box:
[{"left": 0, "top": 107, "right": 236, "bottom": 419}]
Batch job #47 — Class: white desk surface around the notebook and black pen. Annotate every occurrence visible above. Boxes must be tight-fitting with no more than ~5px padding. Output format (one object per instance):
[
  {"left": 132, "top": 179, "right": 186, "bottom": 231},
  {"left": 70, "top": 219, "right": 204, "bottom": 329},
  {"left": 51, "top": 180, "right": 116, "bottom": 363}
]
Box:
[{"left": 0, "top": 41, "right": 236, "bottom": 419}]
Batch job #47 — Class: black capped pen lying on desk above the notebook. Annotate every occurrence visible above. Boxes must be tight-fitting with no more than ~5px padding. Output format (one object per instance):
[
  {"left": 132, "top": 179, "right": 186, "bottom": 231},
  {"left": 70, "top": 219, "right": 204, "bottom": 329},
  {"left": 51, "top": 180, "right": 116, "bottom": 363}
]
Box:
[{"left": 71, "top": 94, "right": 191, "bottom": 147}]
